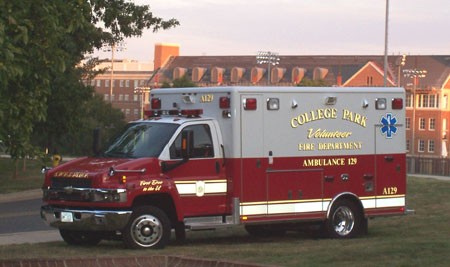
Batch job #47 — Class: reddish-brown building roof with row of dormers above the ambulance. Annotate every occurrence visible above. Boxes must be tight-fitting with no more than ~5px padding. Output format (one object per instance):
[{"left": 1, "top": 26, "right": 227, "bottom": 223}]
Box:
[{"left": 152, "top": 55, "right": 450, "bottom": 89}]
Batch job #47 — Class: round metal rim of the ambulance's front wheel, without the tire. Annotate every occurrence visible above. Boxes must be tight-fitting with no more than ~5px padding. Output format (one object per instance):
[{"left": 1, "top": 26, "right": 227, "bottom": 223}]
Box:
[{"left": 131, "top": 215, "right": 163, "bottom": 247}]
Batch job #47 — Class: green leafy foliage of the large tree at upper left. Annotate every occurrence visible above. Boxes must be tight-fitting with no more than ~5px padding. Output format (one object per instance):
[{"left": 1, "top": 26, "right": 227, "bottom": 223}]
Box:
[{"left": 0, "top": 0, "right": 179, "bottom": 165}]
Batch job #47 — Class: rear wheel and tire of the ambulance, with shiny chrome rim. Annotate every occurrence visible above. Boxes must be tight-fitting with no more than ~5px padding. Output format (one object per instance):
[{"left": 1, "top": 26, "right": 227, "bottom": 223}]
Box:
[{"left": 326, "top": 199, "right": 366, "bottom": 238}]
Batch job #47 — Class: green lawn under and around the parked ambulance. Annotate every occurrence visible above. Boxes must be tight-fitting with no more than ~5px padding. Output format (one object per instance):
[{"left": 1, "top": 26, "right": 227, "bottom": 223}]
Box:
[{"left": 0, "top": 158, "right": 450, "bottom": 267}]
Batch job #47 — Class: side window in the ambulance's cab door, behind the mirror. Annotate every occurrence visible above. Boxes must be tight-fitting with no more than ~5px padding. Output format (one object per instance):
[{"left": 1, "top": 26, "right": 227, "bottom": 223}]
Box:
[{"left": 170, "top": 124, "right": 214, "bottom": 159}]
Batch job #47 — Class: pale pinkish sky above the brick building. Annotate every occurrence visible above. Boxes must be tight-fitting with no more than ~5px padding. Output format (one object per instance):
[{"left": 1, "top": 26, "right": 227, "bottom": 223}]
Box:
[{"left": 94, "top": 0, "right": 450, "bottom": 62}]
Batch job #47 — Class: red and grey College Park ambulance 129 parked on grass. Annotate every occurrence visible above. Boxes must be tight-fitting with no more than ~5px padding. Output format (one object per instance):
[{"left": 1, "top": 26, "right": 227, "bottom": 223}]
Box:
[{"left": 41, "top": 87, "right": 407, "bottom": 248}]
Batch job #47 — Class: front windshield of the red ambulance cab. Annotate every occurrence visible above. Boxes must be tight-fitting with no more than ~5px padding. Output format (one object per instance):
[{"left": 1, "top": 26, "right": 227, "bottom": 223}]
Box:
[{"left": 104, "top": 122, "right": 178, "bottom": 158}]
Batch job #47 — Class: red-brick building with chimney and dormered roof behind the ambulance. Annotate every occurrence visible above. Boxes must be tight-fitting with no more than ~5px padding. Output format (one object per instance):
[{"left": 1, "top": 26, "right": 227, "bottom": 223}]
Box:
[{"left": 89, "top": 44, "right": 450, "bottom": 158}]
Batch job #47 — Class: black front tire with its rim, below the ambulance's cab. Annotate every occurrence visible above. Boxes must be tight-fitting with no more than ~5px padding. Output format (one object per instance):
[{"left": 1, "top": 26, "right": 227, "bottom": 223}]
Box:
[{"left": 122, "top": 206, "right": 171, "bottom": 249}]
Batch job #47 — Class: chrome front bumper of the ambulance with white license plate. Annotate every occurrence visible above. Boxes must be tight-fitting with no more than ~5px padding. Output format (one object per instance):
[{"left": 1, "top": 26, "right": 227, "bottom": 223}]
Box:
[{"left": 41, "top": 205, "right": 132, "bottom": 231}]
